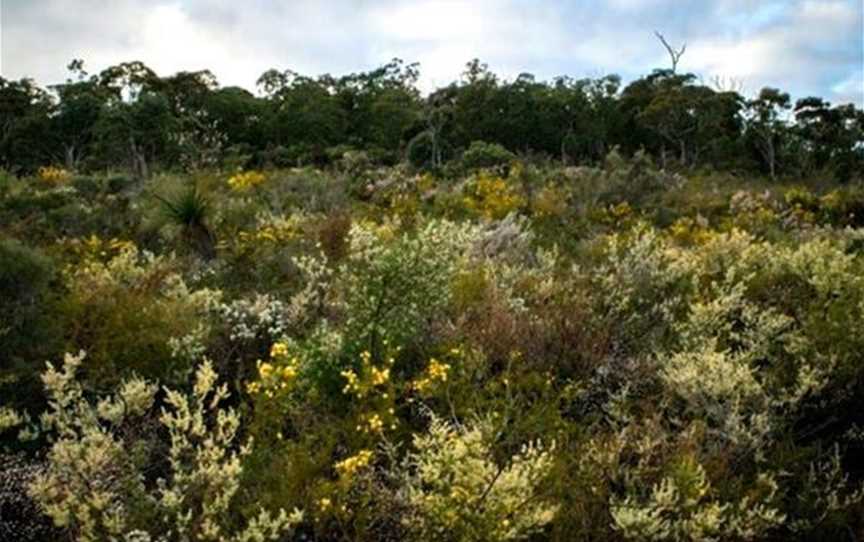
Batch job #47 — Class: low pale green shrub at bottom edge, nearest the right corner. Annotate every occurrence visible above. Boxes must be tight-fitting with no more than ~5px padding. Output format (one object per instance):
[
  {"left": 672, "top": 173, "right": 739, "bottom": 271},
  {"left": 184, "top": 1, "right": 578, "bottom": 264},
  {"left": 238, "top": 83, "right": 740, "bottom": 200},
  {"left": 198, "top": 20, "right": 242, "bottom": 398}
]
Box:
[{"left": 611, "top": 456, "right": 785, "bottom": 542}]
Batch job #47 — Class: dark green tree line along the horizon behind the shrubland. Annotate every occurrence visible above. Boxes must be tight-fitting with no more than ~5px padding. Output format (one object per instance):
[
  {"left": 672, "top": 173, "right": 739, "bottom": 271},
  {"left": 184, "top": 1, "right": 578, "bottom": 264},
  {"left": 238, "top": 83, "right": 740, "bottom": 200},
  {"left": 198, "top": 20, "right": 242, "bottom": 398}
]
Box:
[{"left": 0, "top": 57, "right": 864, "bottom": 180}]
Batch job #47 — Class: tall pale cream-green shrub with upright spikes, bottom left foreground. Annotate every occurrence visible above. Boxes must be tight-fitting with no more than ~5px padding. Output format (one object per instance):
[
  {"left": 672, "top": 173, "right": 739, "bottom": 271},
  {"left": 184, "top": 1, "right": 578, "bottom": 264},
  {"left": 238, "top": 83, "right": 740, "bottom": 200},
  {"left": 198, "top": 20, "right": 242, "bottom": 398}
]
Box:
[{"left": 30, "top": 353, "right": 301, "bottom": 541}]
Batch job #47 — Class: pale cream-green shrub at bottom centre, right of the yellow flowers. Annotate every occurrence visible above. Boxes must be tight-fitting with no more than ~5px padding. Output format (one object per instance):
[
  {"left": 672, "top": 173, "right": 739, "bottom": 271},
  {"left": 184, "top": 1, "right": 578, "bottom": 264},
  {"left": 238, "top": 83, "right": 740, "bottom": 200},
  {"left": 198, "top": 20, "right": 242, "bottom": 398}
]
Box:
[{"left": 402, "top": 417, "right": 558, "bottom": 542}]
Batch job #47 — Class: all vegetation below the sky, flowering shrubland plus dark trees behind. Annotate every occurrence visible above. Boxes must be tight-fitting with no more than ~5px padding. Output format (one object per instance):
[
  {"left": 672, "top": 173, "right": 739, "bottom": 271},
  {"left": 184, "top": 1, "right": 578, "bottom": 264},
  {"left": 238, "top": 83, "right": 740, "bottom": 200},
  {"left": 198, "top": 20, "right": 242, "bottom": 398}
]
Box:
[{"left": 0, "top": 57, "right": 864, "bottom": 542}]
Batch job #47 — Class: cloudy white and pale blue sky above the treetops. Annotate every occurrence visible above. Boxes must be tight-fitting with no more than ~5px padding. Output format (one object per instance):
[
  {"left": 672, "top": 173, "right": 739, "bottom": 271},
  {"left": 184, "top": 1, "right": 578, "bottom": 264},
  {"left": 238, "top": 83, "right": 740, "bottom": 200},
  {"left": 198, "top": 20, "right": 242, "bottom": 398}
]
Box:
[{"left": 0, "top": 0, "right": 864, "bottom": 106}]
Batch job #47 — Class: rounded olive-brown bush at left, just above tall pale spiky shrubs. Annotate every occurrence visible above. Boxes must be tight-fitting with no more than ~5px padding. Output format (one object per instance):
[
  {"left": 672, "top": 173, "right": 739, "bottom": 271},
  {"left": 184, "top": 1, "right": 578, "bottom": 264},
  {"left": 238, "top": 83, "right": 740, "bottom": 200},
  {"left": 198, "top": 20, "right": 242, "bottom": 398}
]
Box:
[{"left": 59, "top": 246, "right": 221, "bottom": 389}]
